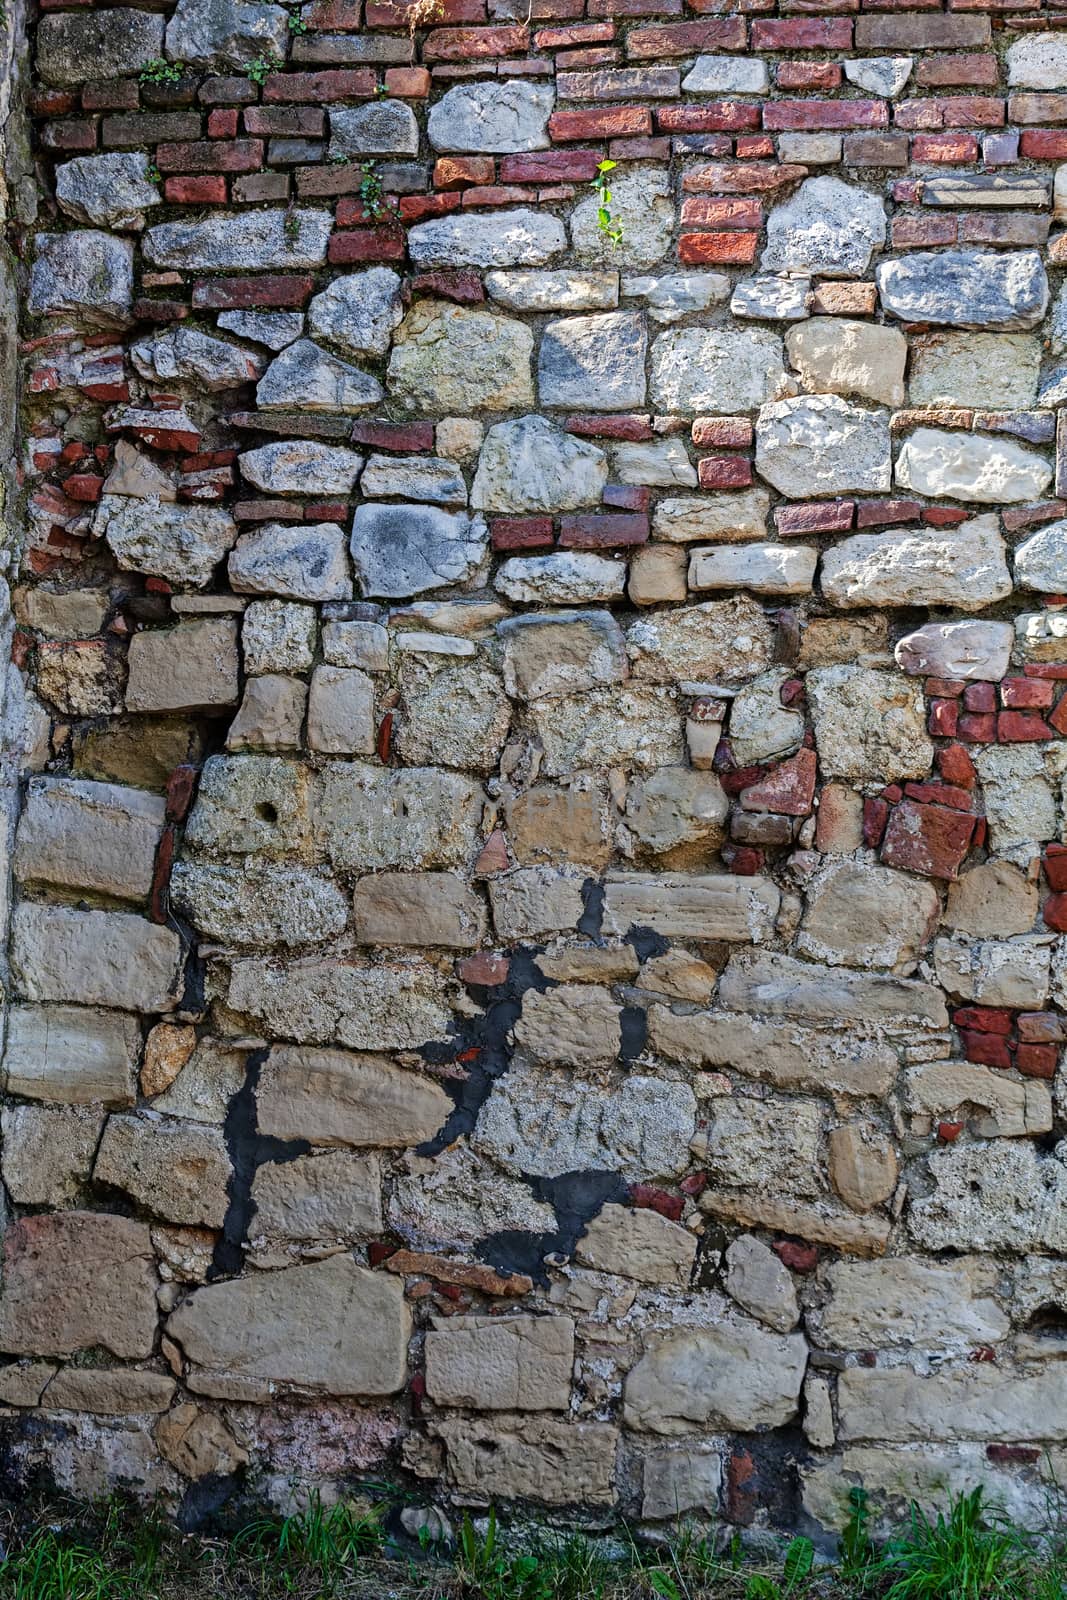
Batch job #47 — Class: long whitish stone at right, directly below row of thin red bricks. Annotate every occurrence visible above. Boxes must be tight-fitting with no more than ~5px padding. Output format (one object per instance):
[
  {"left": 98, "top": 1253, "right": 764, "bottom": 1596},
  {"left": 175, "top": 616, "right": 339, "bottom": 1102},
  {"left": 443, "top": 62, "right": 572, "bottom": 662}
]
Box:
[{"left": 821, "top": 515, "right": 1011, "bottom": 610}]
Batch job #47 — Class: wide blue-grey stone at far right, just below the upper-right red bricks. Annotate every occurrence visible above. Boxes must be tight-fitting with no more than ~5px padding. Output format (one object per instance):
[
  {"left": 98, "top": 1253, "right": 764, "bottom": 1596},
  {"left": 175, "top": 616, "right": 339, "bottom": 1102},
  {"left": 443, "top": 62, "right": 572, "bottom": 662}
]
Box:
[{"left": 875, "top": 250, "right": 1048, "bottom": 330}]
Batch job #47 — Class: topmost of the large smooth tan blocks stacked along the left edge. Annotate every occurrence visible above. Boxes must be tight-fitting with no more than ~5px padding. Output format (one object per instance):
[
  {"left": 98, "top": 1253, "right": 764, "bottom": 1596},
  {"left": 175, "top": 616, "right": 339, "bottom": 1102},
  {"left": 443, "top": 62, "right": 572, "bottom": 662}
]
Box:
[{"left": 14, "top": 778, "right": 165, "bottom": 899}]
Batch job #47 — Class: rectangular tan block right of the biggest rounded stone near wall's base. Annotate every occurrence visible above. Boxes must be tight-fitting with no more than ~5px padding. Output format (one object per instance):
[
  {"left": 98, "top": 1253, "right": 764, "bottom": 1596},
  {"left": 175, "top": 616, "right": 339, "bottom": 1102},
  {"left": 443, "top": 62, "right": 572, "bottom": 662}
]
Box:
[{"left": 426, "top": 1317, "right": 574, "bottom": 1411}]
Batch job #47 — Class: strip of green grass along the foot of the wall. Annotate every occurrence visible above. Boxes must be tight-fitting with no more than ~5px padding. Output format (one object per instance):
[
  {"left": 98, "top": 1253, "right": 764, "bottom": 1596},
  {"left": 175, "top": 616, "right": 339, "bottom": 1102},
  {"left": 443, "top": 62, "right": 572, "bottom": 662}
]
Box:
[{"left": 0, "top": 1490, "right": 1067, "bottom": 1600}]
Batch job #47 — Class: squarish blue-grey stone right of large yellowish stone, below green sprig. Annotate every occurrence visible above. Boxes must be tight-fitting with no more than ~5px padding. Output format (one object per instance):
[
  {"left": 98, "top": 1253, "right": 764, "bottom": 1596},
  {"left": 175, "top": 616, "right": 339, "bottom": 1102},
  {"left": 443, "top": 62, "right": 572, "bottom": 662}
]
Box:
[{"left": 537, "top": 312, "right": 648, "bottom": 411}]
